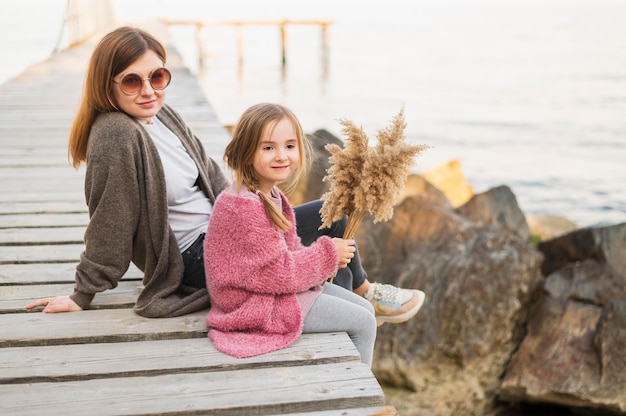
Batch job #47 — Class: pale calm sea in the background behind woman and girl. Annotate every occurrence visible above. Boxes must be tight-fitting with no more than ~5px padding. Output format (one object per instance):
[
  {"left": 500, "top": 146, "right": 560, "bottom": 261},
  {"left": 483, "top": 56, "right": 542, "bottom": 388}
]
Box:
[{"left": 0, "top": 0, "right": 626, "bottom": 226}]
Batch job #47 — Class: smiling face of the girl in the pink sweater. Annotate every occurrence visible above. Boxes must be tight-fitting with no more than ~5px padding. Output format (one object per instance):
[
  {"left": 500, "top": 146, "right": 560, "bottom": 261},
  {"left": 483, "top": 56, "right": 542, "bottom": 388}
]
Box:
[{"left": 252, "top": 117, "right": 300, "bottom": 194}]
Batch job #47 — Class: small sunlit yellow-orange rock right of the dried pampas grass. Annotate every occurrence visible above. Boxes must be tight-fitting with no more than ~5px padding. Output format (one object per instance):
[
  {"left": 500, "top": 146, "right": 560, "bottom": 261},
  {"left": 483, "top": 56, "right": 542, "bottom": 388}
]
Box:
[{"left": 420, "top": 159, "right": 474, "bottom": 208}]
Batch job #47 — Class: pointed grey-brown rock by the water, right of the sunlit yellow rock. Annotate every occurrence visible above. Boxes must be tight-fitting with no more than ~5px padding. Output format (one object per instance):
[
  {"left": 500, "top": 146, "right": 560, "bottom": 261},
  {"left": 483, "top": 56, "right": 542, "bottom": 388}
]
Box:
[{"left": 457, "top": 185, "right": 530, "bottom": 239}]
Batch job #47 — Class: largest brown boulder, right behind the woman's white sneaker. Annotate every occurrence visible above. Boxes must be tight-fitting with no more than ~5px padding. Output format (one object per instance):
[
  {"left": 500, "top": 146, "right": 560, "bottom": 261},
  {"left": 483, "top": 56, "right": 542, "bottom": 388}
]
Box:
[{"left": 357, "top": 190, "right": 542, "bottom": 416}]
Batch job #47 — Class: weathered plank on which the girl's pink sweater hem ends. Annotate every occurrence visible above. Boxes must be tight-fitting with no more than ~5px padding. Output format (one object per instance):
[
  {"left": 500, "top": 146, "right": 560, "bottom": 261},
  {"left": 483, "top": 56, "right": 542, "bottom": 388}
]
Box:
[{"left": 0, "top": 332, "right": 360, "bottom": 384}]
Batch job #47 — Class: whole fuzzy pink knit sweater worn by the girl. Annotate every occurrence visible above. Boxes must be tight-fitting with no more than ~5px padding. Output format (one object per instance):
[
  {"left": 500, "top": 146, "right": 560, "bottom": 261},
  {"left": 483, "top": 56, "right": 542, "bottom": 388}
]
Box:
[{"left": 204, "top": 187, "right": 337, "bottom": 357}]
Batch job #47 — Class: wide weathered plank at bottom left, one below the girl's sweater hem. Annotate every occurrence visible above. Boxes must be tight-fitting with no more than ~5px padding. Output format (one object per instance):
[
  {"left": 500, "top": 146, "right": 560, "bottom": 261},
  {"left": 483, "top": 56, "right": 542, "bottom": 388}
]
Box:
[{"left": 0, "top": 362, "right": 384, "bottom": 416}]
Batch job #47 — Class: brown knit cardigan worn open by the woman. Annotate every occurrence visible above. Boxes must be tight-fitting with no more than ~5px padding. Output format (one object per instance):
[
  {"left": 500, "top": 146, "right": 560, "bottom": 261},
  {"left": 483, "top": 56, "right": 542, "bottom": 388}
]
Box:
[{"left": 71, "top": 105, "right": 228, "bottom": 317}]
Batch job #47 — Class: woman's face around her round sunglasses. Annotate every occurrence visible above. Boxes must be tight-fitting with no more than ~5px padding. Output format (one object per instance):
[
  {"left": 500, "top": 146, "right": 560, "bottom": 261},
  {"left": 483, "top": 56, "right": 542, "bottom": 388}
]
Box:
[{"left": 113, "top": 50, "right": 165, "bottom": 123}]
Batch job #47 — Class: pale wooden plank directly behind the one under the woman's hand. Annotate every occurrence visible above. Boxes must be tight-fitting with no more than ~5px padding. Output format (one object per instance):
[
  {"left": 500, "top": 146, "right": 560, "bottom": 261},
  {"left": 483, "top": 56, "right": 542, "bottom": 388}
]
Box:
[{"left": 0, "top": 261, "right": 143, "bottom": 286}]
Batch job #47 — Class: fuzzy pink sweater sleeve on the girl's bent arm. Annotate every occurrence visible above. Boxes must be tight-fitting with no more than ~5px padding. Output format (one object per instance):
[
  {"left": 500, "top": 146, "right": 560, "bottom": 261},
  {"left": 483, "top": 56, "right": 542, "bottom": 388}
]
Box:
[{"left": 205, "top": 192, "right": 337, "bottom": 294}]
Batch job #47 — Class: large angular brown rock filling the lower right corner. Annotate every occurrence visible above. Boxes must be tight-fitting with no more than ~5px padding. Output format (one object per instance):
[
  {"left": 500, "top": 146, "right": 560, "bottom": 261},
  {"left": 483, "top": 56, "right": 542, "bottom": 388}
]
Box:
[{"left": 500, "top": 224, "right": 626, "bottom": 414}]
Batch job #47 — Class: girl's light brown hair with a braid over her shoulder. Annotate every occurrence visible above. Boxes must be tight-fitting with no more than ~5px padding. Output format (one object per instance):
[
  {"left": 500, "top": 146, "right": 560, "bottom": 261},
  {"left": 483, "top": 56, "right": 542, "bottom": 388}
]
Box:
[{"left": 224, "top": 103, "right": 310, "bottom": 231}]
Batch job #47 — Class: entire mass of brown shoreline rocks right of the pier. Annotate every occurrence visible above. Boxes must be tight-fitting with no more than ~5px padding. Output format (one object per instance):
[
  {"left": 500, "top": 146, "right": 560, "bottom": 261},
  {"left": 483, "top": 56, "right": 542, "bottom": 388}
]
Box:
[{"left": 293, "top": 130, "right": 626, "bottom": 416}]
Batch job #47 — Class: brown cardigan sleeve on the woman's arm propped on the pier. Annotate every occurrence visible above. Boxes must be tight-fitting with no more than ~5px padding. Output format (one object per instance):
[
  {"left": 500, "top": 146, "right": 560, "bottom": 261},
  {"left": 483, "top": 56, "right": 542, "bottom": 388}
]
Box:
[{"left": 71, "top": 113, "right": 140, "bottom": 309}]
